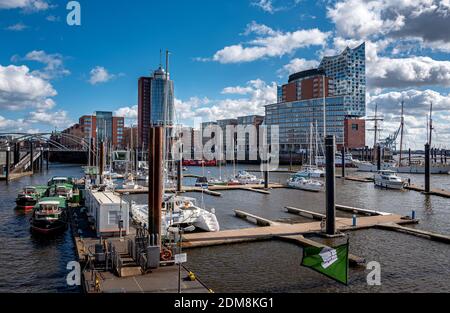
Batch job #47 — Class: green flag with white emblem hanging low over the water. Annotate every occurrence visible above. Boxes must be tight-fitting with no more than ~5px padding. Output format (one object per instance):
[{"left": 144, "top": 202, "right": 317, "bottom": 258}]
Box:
[{"left": 302, "top": 242, "right": 348, "bottom": 285}]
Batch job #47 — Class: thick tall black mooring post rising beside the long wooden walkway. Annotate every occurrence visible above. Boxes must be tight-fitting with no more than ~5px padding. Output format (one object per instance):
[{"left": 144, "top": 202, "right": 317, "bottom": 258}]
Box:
[{"left": 325, "top": 135, "right": 336, "bottom": 235}]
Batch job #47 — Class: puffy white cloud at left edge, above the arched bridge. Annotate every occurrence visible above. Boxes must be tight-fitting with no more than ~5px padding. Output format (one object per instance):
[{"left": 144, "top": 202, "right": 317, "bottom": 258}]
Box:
[{"left": 0, "top": 65, "right": 57, "bottom": 110}]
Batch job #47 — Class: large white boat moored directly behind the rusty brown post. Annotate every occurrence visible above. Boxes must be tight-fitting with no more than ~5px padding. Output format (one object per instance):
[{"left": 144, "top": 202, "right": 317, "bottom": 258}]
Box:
[{"left": 131, "top": 195, "right": 220, "bottom": 235}]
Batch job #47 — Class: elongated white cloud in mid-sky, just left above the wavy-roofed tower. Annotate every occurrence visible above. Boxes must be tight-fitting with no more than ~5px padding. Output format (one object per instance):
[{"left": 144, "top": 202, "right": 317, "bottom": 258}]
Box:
[{"left": 206, "top": 22, "right": 329, "bottom": 63}]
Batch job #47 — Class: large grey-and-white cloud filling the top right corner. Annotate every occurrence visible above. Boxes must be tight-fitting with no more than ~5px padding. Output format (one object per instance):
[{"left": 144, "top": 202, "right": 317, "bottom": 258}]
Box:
[{"left": 327, "top": 0, "right": 450, "bottom": 51}]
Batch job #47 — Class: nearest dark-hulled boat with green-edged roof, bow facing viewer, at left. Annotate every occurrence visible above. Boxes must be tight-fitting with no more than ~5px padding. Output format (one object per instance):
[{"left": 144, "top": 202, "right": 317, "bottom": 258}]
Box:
[{"left": 30, "top": 197, "right": 67, "bottom": 235}]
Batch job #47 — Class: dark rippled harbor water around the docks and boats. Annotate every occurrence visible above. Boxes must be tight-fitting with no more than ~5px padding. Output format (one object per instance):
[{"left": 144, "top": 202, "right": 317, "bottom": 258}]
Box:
[{"left": 0, "top": 164, "right": 450, "bottom": 292}]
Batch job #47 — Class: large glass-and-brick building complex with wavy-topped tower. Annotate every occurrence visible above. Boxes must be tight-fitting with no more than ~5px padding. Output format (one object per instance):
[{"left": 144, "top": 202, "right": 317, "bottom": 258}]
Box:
[{"left": 265, "top": 43, "right": 366, "bottom": 154}]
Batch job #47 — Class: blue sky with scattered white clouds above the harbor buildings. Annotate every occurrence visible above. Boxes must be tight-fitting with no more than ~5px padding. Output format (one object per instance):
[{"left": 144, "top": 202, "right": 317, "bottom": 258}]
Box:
[{"left": 0, "top": 0, "right": 450, "bottom": 148}]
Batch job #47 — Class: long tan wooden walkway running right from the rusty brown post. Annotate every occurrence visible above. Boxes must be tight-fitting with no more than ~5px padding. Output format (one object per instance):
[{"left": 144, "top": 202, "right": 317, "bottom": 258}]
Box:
[{"left": 183, "top": 214, "right": 417, "bottom": 248}]
